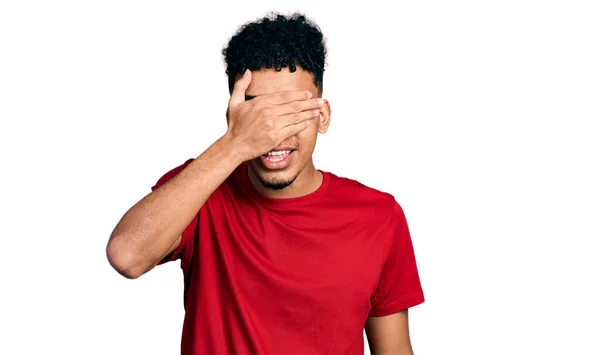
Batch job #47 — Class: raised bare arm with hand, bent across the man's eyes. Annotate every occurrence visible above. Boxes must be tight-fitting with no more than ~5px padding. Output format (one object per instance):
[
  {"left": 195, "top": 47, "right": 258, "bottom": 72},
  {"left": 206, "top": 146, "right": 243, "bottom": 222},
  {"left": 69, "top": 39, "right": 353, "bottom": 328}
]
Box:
[{"left": 106, "top": 70, "right": 324, "bottom": 279}]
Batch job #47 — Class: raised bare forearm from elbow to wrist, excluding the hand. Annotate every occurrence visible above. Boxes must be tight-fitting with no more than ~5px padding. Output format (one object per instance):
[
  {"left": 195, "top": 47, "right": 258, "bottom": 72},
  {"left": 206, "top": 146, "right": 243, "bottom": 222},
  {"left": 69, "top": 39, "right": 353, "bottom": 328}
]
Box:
[{"left": 106, "top": 136, "right": 242, "bottom": 278}]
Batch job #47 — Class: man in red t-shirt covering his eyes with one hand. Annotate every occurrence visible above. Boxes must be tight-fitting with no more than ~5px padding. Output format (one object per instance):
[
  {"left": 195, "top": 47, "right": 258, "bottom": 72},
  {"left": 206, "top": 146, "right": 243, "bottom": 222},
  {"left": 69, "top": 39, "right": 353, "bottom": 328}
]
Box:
[{"left": 107, "top": 14, "right": 424, "bottom": 355}]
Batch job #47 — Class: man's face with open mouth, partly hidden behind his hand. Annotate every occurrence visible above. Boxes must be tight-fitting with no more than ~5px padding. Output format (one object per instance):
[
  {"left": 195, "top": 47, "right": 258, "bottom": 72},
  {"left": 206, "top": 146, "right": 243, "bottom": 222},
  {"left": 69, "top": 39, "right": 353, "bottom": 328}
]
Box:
[{"left": 233, "top": 66, "right": 331, "bottom": 190}]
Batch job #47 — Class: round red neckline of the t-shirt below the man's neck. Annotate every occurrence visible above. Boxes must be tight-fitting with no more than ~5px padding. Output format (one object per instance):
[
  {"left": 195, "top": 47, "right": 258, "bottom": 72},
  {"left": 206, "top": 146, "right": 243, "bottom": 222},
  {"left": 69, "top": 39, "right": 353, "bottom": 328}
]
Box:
[{"left": 233, "top": 162, "right": 331, "bottom": 209}]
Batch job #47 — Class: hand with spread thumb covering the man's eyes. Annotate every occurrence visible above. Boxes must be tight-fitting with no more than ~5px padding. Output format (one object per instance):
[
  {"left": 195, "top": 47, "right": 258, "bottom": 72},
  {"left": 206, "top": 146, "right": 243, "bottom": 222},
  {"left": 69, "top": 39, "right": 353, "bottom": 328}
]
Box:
[{"left": 227, "top": 70, "right": 323, "bottom": 161}]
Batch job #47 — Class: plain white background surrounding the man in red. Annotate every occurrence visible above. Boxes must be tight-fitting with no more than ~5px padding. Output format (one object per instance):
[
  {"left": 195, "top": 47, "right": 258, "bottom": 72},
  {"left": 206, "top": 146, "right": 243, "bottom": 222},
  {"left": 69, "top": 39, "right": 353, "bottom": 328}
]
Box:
[{"left": 0, "top": 0, "right": 600, "bottom": 355}]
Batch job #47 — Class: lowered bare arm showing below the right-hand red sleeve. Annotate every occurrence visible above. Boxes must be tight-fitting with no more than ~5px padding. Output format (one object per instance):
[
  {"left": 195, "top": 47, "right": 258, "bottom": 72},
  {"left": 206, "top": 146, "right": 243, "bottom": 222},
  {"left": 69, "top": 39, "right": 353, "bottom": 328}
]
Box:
[{"left": 365, "top": 309, "right": 414, "bottom": 355}]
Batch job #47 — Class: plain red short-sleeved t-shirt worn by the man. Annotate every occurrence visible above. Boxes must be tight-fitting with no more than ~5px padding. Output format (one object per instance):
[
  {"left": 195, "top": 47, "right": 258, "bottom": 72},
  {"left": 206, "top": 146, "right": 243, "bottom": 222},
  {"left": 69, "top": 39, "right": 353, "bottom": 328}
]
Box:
[{"left": 152, "top": 159, "right": 425, "bottom": 355}]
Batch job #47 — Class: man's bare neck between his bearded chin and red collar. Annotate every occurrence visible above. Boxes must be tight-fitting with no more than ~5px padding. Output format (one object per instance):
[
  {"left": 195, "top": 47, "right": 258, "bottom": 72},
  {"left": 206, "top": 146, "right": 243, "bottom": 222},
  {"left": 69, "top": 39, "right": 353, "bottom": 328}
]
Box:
[{"left": 248, "top": 159, "right": 323, "bottom": 198}]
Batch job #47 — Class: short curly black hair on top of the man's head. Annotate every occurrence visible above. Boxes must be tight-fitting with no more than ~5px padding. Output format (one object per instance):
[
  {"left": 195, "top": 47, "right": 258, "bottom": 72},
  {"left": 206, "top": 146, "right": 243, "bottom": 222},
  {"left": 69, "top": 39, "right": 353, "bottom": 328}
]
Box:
[{"left": 222, "top": 12, "right": 327, "bottom": 96}]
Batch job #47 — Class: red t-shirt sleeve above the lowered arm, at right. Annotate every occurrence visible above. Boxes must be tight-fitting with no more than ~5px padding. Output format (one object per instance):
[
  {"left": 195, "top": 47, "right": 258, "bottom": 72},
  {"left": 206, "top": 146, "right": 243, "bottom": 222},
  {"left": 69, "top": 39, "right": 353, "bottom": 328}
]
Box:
[{"left": 369, "top": 200, "right": 425, "bottom": 317}]
